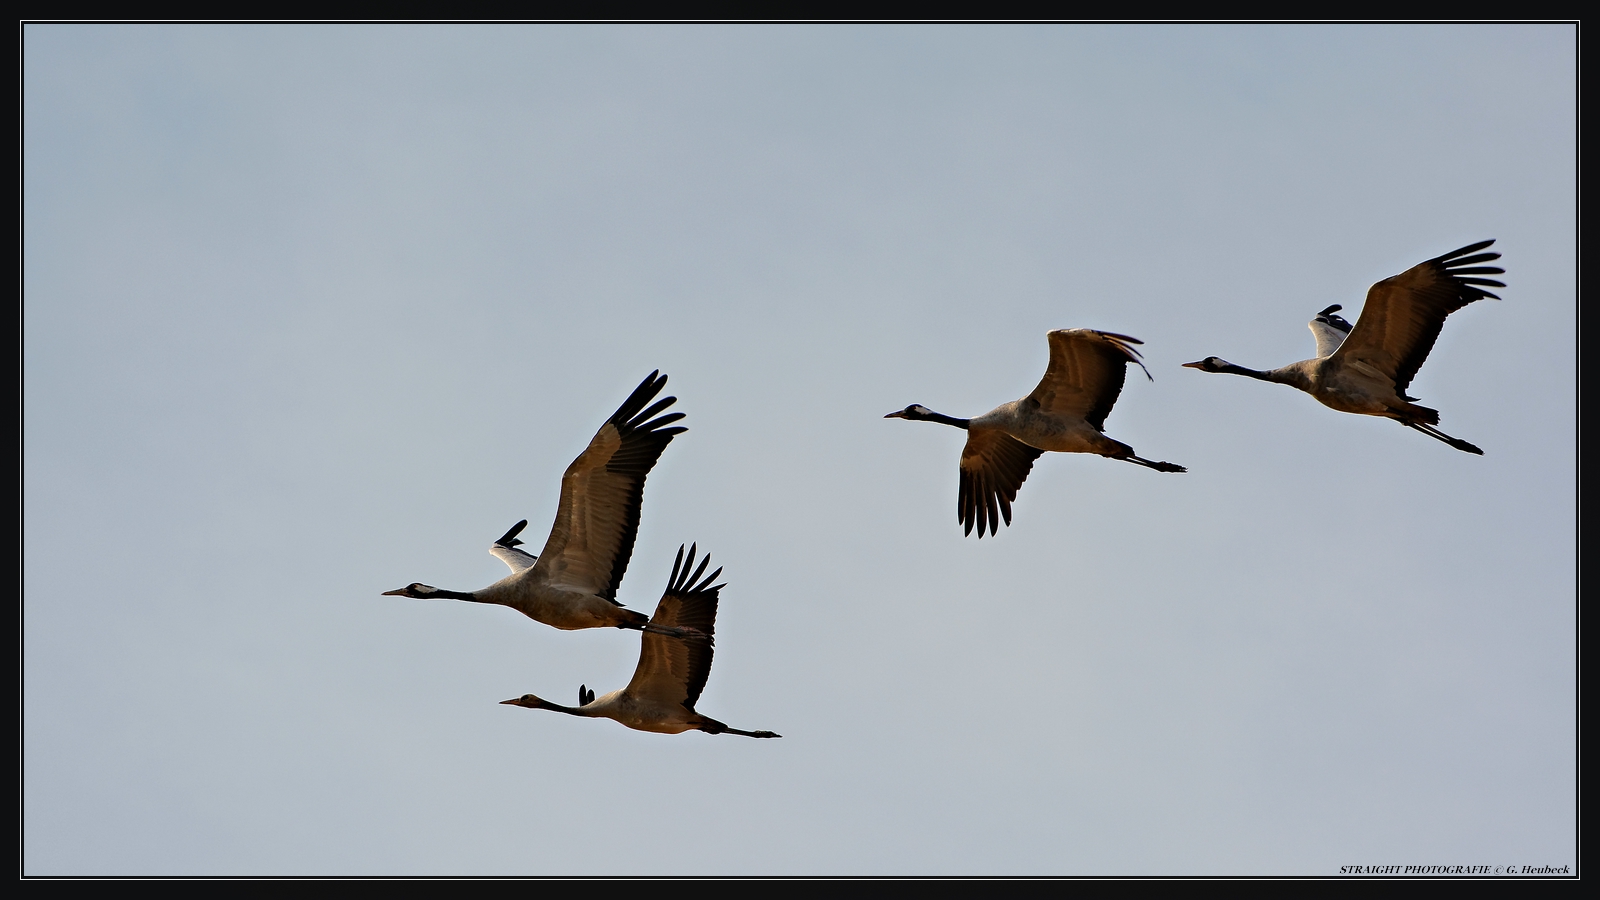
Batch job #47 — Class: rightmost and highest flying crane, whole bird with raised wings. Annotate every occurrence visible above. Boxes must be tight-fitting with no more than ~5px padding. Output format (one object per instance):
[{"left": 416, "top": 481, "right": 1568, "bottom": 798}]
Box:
[{"left": 1184, "top": 240, "right": 1506, "bottom": 456}]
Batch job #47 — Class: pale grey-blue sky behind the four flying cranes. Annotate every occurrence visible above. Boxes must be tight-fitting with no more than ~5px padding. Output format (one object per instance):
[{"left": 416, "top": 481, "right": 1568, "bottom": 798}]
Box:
[{"left": 21, "top": 24, "right": 1578, "bottom": 878}]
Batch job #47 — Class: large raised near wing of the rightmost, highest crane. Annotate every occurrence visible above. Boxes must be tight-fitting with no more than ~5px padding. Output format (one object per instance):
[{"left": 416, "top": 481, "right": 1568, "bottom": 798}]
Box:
[{"left": 1334, "top": 240, "right": 1506, "bottom": 397}]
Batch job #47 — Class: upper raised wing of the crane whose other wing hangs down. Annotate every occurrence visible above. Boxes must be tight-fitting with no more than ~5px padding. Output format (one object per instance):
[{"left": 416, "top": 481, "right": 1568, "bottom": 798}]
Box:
[{"left": 1019, "top": 328, "right": 1150, "bottom": 432}]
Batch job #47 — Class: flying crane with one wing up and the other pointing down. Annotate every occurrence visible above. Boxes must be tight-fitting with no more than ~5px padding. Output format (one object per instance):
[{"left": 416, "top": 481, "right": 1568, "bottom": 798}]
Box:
[{"left": 883, "top": 328, "right": 1187, "bottom": 538}]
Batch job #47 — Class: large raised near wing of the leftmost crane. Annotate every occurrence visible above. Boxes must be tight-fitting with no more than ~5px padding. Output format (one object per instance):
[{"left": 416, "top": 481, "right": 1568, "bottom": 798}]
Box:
[{"left": 534, "top": 372, "right": 688, "bottom": 602}]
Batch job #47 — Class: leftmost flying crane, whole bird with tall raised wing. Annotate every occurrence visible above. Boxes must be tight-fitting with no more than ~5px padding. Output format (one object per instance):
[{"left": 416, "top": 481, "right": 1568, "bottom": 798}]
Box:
[{"left": 384, "top": 372, "right": 694, "bottom": 637}]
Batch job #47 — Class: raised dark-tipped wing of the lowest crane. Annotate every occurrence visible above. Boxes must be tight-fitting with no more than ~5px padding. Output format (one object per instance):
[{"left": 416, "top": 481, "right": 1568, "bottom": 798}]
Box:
[{"left": 624, "top": 544, "right": 723, "bottom": 711}]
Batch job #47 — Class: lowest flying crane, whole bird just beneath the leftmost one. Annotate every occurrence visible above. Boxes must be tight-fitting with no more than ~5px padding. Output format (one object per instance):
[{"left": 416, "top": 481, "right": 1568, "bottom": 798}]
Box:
[{"left": 501, "top": 544, "right": 782, "bottom": 738}]
